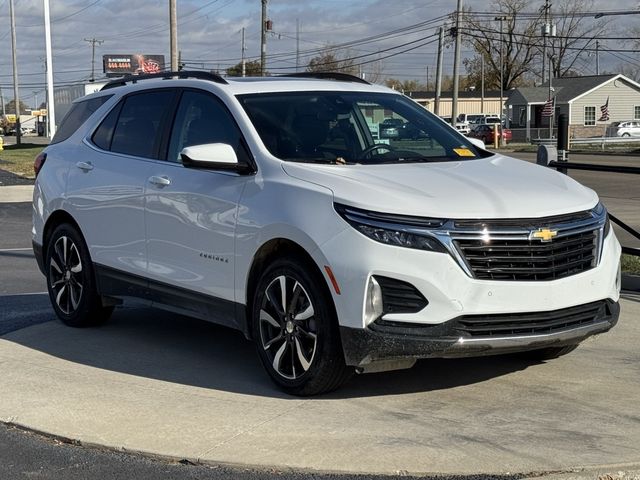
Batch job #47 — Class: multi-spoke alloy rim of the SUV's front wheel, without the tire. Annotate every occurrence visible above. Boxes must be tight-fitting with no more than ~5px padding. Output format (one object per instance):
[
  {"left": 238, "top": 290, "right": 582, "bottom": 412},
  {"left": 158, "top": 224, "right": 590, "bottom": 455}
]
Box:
[{"left": 259, "top": 275, "right": 318, "bottom": 380}]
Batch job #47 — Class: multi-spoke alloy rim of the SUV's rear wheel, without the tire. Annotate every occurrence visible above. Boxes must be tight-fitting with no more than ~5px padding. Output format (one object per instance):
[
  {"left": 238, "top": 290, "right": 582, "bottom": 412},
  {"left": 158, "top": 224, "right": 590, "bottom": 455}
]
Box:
[{"left": 49, "top": 236, "right": 84, "bottom": 315}]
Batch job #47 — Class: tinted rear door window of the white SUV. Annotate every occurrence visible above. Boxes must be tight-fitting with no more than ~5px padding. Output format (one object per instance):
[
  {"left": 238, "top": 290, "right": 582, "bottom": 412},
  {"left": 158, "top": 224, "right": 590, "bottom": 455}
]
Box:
[{"left": 111, "top": 90, "right": 174, "bottom": 158}]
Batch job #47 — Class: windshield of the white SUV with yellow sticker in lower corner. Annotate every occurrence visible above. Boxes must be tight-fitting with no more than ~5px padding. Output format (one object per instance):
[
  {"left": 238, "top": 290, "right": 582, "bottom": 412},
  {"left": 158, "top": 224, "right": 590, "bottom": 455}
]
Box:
[{"left": 238, "top": 91, "right": 491, "bottom": 164}]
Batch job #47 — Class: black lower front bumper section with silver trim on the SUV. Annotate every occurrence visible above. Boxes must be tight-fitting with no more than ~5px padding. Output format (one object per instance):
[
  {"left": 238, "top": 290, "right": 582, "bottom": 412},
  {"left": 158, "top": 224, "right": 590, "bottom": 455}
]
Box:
[{"left": 340, "top": 300, "right": 620, "bottom": 371}]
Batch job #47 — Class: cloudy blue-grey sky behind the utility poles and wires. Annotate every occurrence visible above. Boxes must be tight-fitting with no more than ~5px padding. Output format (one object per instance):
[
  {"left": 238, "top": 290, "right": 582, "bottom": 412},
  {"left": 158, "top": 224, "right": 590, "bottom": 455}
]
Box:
[{"left": 0, "top": 0, "right": 640, "bottom": 106}]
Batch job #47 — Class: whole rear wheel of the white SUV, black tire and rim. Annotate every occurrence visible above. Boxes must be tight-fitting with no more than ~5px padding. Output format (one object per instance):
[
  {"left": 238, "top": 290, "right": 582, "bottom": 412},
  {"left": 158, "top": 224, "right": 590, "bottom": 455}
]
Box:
[{"left": 45, "top": 223, "right": 113, "bottom": 327}]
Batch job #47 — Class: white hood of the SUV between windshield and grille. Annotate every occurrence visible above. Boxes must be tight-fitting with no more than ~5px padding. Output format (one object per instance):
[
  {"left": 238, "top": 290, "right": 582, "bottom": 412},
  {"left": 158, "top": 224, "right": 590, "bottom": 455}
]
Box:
[{"left": 283, "top": 155, "right": 598, "bottom": 219}]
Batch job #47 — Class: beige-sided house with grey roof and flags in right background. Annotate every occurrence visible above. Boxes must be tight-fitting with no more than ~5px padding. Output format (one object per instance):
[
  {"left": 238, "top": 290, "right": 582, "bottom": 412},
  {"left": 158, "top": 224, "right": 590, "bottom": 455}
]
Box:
[{"left": 505, "top": 74, "right": 640, "bottom": 141}]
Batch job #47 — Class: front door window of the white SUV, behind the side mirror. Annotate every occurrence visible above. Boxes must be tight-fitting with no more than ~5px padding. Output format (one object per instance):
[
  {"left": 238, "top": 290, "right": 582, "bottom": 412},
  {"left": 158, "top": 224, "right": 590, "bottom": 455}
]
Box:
[{"left": 167, "top": 91, "right": 248, "bottom": 162}]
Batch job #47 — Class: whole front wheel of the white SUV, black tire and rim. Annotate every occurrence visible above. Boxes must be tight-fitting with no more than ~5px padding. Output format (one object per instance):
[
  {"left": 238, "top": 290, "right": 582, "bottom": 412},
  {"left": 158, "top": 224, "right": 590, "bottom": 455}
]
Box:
[{"left": 251, "top": 258, "right": 353, "bottom": 396}]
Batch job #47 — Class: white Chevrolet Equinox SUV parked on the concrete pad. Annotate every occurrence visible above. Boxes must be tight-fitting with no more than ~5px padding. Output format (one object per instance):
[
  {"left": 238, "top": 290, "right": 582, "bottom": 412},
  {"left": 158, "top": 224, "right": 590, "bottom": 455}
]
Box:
[{"left": 33, "top": 72, "right": 620, "bottom": 395}]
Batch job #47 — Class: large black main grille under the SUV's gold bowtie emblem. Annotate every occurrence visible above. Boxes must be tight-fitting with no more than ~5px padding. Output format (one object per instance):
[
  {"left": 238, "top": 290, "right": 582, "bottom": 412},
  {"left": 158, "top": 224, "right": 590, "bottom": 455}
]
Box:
[{"left": 455, "top": 230, "right": 597, "bottom": 281}]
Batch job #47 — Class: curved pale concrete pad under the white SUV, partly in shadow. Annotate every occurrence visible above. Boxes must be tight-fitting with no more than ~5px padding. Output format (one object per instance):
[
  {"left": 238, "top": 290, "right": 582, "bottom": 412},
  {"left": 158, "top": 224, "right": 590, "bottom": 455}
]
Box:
[{"left": 0, "top": 297, "right": 640, "bottom": 478}]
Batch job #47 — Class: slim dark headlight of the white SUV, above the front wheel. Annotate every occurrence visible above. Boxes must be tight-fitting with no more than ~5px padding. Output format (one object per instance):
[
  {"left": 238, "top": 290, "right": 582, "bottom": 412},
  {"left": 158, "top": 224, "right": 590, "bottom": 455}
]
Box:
[{"left": 335, "top": 203, "right": 447, "bottom": 253}]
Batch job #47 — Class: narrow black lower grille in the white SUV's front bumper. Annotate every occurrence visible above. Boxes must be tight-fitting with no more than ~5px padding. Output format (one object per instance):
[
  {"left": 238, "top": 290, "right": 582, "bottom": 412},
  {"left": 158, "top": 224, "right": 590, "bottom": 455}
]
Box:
[{"left": 457, "top": 300, "right": 611, "bottom": 337}]
